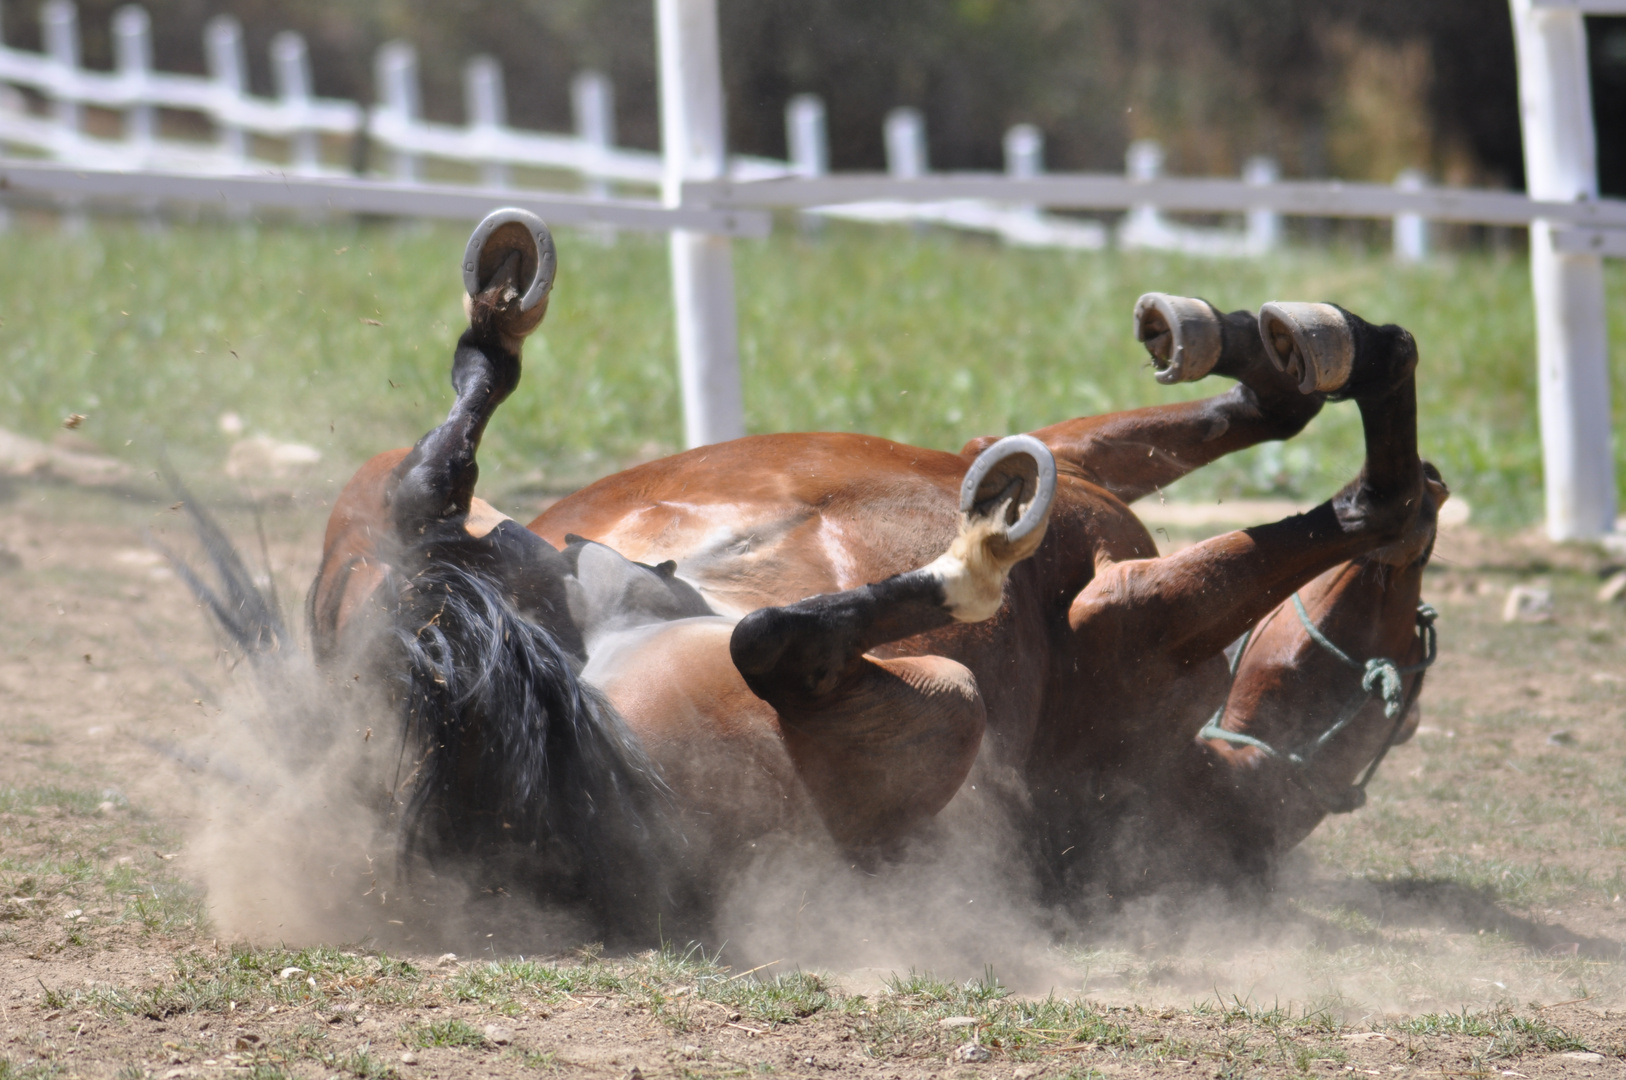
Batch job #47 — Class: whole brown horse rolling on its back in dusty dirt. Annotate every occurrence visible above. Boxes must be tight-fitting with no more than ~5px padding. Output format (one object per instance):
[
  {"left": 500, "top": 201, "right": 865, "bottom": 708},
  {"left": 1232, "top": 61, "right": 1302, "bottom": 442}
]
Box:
[{"left": 292, "top": 211, "right": 1447, "bottom": 935}]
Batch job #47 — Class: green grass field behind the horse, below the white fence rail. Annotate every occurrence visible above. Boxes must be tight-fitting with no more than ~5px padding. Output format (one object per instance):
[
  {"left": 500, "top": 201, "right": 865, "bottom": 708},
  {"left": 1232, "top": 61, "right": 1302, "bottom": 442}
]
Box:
[{"left": 0, "top": 217, "right": 1626, "bottom": 525}]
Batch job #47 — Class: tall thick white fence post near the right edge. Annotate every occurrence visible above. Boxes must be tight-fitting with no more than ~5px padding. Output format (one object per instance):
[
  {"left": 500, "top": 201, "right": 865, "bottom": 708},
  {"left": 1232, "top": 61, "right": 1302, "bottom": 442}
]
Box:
[{"left": 1512, "top": 0, "right": 1615, "bottom": 540}]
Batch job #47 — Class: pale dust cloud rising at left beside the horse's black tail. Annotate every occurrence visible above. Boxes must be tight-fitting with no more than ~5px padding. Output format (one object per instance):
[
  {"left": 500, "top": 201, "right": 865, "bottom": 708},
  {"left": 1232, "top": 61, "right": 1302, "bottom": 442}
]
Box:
[{"left": 189, "top": 640, "right": 585, "bottom": 953}]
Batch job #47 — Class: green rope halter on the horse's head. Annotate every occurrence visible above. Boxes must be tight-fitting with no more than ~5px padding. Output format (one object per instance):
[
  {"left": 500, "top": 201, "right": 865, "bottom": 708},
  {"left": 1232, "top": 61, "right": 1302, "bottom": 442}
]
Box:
[{"left": 1197, "top": 592, "right": 1439, "bottom": 813}]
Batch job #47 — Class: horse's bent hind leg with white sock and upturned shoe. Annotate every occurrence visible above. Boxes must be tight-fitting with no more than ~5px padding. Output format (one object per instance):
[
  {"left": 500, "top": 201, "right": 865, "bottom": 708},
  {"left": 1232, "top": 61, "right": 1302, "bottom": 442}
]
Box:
[{"left": 730, "top": 436, "right": 1055, "bottom": 847}]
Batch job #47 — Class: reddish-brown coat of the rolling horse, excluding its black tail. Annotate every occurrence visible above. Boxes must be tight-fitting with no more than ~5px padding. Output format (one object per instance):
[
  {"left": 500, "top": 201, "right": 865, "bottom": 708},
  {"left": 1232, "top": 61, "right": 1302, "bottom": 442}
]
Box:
[{"left": 311, "top": 239, "right": 1446, "bottom": 930}]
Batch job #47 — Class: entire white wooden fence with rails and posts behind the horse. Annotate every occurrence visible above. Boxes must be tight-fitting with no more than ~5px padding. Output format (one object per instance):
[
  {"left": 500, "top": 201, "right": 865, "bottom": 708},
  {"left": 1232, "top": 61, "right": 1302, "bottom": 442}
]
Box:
[{"left": 0, "top": 0, "right": 1626, "bottom": 538}]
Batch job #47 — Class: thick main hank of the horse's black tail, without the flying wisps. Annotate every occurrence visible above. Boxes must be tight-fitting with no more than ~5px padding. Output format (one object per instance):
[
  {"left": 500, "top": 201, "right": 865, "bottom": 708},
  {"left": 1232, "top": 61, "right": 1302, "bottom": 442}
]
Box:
[{"left": 377, "top": 542, "right": 681, "bottom": 935}]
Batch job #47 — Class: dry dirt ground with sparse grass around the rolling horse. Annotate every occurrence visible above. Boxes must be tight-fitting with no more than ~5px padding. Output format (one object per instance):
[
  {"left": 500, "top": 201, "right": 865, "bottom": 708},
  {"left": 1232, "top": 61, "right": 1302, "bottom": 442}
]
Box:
[{"left": 0, "top": 481, "right": 1626, "bottom": 1080}]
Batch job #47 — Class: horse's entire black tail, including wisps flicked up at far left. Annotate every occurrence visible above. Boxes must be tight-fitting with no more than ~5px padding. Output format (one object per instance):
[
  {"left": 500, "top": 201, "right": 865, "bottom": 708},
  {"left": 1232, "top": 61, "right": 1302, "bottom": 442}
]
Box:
[{"left": 165, "top": 465, "right": 691, "bottom": 940}]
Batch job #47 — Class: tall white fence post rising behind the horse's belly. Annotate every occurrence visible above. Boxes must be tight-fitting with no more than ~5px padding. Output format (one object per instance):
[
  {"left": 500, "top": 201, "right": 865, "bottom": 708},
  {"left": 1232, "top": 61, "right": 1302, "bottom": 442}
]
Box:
[{"left": 655, "top": 0, "right": 745, "bottom": 447}]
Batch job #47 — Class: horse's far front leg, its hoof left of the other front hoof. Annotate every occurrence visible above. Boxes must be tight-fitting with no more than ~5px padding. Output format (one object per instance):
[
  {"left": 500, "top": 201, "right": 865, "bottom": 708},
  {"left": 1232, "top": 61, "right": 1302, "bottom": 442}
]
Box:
[{"left": 1001, "top": 293, "right": 1325, "bottom": 503}]
